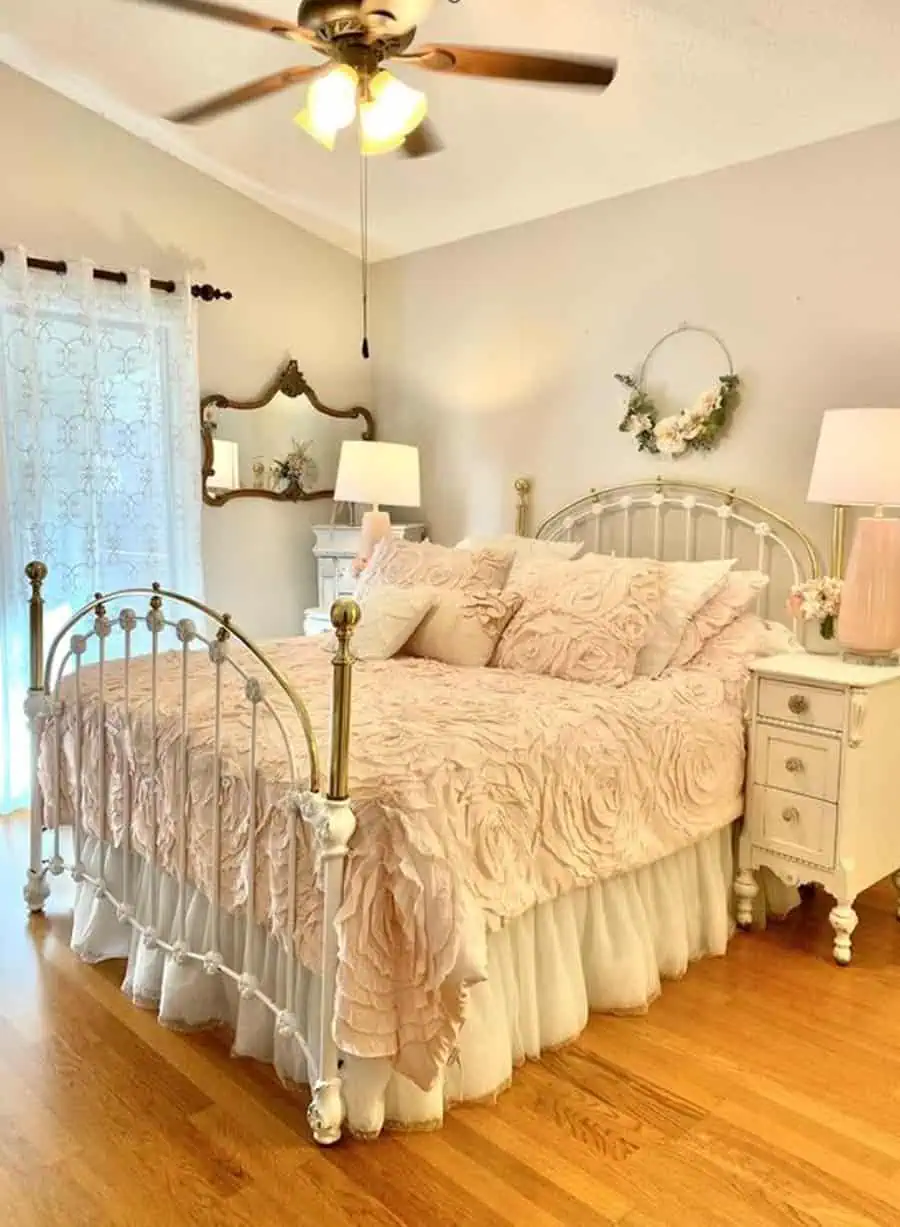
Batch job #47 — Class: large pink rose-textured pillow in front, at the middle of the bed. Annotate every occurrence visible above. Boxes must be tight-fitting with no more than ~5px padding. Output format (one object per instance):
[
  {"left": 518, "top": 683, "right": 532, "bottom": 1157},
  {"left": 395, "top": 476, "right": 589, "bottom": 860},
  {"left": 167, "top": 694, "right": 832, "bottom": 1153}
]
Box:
[{"left": 494, "top": 555, "right": 662, "bottom": 686}]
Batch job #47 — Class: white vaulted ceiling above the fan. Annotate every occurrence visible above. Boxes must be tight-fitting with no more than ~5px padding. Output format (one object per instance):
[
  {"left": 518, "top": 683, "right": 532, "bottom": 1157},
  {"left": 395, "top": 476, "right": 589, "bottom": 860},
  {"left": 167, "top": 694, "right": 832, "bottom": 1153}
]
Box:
[{"left": 0, "top": 0, "right": 900, "bottom": 256}]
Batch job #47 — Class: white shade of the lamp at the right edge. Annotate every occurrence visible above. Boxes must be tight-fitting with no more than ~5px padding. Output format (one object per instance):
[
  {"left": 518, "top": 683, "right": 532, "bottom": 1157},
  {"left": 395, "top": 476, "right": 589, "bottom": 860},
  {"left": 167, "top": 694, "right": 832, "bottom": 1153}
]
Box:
[{"left": 807, "top": 409, "right": 900, "bottom": 507}]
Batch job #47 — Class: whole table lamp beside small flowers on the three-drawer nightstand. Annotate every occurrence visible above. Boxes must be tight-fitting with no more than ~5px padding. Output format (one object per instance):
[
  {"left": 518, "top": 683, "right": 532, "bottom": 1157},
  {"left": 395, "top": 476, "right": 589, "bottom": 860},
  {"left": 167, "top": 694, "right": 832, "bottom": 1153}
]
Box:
[{"left": 808, "top": 409, "right": 900, "bottom": 665}]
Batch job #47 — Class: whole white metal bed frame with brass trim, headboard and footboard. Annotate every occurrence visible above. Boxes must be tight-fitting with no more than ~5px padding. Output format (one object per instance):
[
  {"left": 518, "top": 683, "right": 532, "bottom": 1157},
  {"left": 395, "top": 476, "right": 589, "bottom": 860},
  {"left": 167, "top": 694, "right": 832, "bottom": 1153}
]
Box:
[{"left": 25, "top": 479, "right": 819, "bottom": 1146}]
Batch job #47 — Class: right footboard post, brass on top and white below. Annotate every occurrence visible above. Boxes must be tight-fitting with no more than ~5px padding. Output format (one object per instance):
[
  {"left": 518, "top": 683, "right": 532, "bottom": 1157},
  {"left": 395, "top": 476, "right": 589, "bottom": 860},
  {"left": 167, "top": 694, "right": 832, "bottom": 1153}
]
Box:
[{"left": 308, "top": 600, "right": 361, "bottom": 1146}]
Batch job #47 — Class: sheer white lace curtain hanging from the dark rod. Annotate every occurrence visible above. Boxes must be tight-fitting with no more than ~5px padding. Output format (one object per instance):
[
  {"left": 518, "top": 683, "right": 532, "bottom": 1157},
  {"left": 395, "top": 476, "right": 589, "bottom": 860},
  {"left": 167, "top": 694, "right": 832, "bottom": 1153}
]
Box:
[{"left": 0, "top": 249, "right": 203, "bottom": 812}]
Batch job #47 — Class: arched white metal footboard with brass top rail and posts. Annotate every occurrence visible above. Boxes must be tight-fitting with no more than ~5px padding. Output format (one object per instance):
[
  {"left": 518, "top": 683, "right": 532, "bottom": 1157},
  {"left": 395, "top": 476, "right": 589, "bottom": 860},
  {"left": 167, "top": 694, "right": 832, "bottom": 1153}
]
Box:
[{"left": 23, "top": 562, "right": 360, "bottom": 1146}]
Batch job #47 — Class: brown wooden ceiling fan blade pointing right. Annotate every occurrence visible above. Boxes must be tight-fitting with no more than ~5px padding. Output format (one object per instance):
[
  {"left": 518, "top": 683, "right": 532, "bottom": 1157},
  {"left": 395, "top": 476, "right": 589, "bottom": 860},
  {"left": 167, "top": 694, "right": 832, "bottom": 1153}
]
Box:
[{"left": 395, "top": 44, "right": 618, "bottom": 90}]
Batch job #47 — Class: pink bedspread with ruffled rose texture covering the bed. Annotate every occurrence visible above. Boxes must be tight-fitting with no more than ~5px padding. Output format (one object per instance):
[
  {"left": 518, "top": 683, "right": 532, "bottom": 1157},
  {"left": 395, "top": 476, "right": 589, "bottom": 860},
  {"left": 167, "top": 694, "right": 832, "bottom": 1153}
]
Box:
[{"left": 41, "top": 639, "right": 744, "bottom": 1087}]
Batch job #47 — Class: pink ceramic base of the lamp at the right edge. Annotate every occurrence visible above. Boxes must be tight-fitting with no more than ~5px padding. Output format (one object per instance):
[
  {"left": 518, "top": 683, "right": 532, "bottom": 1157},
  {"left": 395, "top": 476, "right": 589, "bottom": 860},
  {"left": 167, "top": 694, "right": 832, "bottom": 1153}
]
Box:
[{"left": 837, "top": 515, "right": 900, "bottom": 665}]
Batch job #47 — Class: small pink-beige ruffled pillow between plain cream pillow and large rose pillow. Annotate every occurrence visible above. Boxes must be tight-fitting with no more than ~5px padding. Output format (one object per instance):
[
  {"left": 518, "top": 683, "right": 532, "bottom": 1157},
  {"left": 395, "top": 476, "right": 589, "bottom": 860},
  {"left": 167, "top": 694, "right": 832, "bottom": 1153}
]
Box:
[{"left": 405, "top": 588, "right": 522, "bottom": 667}]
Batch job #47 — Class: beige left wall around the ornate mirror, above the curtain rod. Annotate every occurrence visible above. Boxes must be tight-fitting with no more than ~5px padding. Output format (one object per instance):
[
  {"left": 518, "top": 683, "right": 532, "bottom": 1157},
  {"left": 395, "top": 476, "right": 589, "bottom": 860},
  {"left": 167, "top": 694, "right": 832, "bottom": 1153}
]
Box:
[{"left": 0, "top": 67, "right": 371, "bottom": 636}]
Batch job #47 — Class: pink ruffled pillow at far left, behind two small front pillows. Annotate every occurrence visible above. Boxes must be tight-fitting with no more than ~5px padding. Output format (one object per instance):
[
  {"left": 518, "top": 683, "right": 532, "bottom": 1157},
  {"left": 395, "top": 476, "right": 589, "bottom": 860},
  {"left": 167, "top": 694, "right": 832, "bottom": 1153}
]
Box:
[{"left": 356, "top": 537, "right": 512, "bottom": 599}]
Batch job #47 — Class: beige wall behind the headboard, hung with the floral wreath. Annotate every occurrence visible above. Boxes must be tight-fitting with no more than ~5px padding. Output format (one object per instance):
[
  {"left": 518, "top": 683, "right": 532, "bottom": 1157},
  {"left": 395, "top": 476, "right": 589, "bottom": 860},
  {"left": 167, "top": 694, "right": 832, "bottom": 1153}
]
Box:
[{"left": 373, "top": 115, "right": 900, "bottom": 564}]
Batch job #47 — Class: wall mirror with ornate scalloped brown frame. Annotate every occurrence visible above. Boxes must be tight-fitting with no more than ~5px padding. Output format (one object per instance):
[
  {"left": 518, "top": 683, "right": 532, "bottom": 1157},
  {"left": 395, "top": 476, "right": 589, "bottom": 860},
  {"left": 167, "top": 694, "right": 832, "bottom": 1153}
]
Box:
[{"left": 200, "top": 358, "right": 374, "bottom": 507}]
